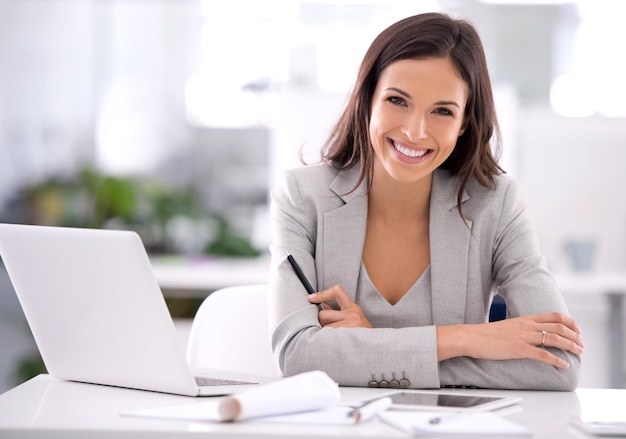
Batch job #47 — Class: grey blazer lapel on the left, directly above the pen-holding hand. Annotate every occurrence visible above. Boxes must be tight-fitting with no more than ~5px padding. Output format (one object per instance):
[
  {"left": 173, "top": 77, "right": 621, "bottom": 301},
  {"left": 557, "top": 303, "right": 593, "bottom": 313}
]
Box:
[{"left": 322, "top": 166, "right": 367, "bottom": 299}]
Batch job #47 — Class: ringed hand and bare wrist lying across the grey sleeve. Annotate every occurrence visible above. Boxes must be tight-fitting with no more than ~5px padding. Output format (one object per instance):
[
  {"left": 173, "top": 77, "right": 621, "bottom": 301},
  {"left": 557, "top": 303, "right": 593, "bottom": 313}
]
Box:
[{"left": 437, "top": 312, "right": 585, "bottom": 368}]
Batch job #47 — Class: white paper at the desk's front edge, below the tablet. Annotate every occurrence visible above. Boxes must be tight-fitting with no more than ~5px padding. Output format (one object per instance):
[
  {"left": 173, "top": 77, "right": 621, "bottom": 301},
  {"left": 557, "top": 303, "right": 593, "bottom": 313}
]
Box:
[{"left": 379, "top": 410, "right": 531, "bottom": 436}]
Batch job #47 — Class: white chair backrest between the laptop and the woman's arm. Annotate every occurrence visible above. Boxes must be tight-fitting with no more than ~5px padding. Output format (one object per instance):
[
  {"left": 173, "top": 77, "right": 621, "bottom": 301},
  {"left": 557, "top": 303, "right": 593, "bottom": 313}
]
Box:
[{"left": 187, "top": 284, "right": 281, "bottom": 377}]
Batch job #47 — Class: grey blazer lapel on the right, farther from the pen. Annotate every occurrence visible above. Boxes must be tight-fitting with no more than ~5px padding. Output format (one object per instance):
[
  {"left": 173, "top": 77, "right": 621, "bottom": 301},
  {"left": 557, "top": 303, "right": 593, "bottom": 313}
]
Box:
[{"left": 429, "top": 171, "right": 472, "bottom": 325}]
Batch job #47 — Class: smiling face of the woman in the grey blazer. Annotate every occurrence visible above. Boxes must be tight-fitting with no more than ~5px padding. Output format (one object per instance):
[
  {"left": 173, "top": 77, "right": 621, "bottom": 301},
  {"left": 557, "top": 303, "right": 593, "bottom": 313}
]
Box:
[{"left": 369, "top": 58, "right": 467, "bottom": 183}]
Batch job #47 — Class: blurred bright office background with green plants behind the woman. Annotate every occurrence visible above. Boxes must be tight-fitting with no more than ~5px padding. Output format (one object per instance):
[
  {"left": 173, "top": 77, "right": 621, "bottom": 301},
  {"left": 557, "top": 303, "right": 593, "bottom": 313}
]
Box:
[{"left": 0, "top": 0, "right": 626, "bottom": 392}]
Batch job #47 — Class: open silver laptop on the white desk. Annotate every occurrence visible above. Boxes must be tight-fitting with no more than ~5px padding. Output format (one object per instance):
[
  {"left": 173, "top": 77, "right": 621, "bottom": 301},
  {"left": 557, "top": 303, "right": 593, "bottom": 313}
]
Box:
[{"left": 0, "top": 224, "right": 272, "bottom": 396}]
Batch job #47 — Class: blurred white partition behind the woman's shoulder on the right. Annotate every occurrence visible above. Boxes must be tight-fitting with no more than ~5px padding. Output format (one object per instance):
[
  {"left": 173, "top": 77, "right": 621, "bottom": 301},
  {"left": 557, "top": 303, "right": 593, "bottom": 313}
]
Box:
[{"left": 517, "top": 107, "right": 626, "bottom": 271}]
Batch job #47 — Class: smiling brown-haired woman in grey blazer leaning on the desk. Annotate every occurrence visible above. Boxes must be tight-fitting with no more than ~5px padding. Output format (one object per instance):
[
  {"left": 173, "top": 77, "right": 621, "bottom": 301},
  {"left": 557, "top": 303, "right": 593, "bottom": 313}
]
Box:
[{"left": 270, "top": 13, "right": 584, "bottom": 390}]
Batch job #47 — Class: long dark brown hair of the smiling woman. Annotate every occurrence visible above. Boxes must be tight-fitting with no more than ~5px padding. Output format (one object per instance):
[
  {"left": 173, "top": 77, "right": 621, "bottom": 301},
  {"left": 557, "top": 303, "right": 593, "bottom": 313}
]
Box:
[{"left": 322, "top": 13, "right": 504, "bottom": 215}]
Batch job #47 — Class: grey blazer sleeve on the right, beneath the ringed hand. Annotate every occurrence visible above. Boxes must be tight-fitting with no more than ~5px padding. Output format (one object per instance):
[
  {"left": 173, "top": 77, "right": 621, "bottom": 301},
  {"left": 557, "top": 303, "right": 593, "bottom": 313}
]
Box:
[{"left": 440, "top": 179, "right": 581, "bottom": 391}]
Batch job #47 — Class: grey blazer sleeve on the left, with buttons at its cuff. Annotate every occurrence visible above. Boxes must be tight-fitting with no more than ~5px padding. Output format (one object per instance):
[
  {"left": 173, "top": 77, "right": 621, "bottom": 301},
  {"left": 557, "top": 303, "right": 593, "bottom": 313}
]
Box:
[{"left": 269, "top": 168, "right": 439, "bottom": 388}]
